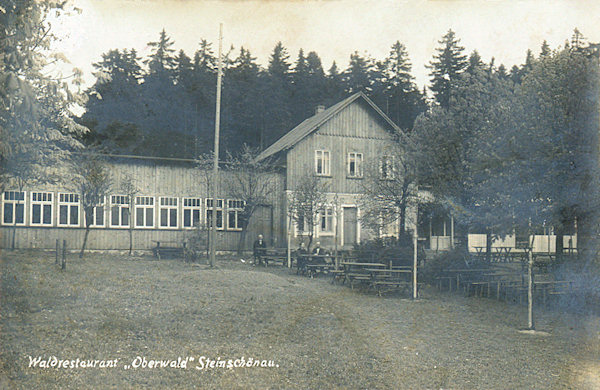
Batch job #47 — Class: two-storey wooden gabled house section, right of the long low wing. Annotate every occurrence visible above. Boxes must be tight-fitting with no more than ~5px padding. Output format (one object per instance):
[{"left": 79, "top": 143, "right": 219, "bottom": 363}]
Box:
[{"left": 258, "top": 92, "right": 410, "bottom": 248}]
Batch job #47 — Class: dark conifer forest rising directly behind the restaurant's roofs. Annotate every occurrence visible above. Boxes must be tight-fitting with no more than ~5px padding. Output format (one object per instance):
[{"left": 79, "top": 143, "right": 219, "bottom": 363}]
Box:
[{"left": 79, "top": 30, "right": 442, "bottom": 157}]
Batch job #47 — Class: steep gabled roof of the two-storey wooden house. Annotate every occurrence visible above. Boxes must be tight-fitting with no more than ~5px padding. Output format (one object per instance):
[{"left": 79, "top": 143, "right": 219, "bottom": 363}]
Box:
[{"left": 257, "top": 92, "right": 400, "bottom": 161}]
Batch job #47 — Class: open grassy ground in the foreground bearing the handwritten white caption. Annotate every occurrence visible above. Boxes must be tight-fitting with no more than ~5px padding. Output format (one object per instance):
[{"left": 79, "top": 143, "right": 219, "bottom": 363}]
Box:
[{"left": 0, "top": 252, "right": 600, "bottom": 389}]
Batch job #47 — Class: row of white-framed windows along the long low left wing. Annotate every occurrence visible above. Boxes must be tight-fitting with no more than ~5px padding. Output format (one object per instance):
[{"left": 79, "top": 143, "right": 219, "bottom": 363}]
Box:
[{"left": 2, "top": 191, "right": 245, "bottom": 230}]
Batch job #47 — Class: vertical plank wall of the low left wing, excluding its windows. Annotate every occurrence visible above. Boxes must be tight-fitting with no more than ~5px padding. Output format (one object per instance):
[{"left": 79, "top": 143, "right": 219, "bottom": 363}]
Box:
[{"left": 0, "top": 159, "right": 285, "bottom": 250}]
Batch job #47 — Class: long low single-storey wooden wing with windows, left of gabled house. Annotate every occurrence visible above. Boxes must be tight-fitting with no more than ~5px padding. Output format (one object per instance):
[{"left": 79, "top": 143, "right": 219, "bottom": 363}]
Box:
[{"left": 0, "top": 156, "right": 283, "bottom": 250}]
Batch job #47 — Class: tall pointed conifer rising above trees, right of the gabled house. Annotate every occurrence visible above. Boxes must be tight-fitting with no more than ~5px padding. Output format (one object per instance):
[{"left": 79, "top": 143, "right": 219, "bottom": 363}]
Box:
[{"left": 429, "top": 30, "right": 467, "bottom": 108}]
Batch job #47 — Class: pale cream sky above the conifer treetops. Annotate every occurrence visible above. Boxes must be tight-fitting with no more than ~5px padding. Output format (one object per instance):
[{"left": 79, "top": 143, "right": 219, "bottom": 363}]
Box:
[{"left": 53, "top": 0, "right": 600, "bottom": 91}]
